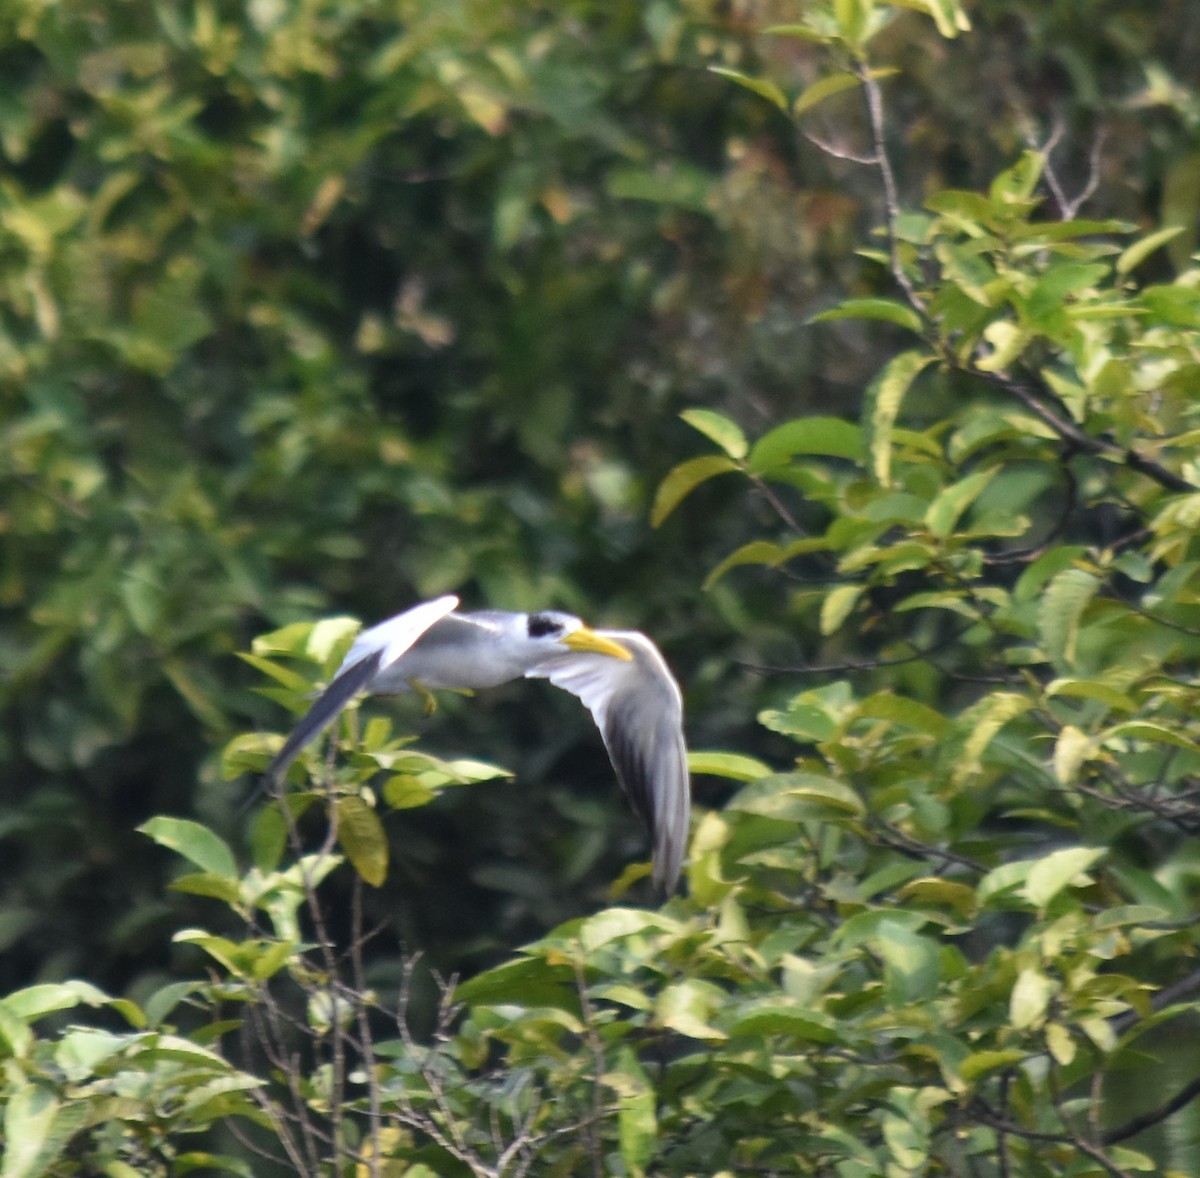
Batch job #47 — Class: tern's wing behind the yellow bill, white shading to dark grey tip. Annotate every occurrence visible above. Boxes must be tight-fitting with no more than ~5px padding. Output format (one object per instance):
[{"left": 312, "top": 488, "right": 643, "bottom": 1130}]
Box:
[{"left": 526, "top": 630, "right": 691, "bottom": 891}]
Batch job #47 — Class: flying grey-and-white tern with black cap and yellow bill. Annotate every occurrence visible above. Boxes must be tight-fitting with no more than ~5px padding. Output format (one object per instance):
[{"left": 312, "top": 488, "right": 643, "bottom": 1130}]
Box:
[{"left": 266, "top": 595, "right": 691, "bottom": 892}]
